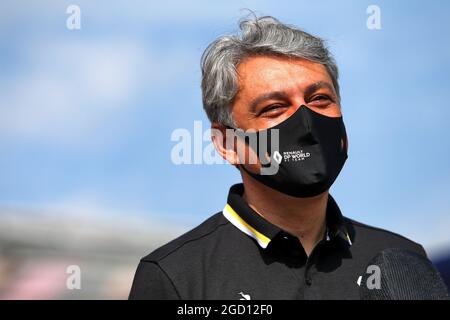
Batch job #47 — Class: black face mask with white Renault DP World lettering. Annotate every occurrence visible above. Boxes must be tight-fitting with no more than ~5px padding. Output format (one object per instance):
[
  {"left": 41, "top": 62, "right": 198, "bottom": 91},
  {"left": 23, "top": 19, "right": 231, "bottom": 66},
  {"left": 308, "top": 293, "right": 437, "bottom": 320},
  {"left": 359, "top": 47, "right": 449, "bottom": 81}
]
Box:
[{"left": 236, "top": 105, "right": 347, "bottom": 198}]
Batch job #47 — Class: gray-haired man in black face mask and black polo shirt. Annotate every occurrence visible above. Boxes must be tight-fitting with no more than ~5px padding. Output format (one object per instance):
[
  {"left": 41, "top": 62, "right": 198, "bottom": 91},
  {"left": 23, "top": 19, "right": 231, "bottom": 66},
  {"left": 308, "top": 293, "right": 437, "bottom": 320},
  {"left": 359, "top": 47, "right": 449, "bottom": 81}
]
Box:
[{"left": 130, "top": 17, "right": 426, "bottom": 299}]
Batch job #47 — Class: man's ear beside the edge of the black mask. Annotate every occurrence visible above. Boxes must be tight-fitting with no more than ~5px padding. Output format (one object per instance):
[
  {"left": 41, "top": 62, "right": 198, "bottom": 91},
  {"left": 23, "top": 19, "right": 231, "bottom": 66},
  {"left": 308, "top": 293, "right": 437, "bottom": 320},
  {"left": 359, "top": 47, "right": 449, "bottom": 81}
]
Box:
[{"left": 211, "top": 122, "right": 239, "bottom": 166}]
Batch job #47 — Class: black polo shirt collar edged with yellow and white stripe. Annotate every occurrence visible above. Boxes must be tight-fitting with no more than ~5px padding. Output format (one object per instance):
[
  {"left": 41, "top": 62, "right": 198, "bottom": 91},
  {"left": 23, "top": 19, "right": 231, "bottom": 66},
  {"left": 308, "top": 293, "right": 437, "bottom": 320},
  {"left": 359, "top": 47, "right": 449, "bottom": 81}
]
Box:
[{"left": 222, "top": 183, "right": 352, "bottom": 249}]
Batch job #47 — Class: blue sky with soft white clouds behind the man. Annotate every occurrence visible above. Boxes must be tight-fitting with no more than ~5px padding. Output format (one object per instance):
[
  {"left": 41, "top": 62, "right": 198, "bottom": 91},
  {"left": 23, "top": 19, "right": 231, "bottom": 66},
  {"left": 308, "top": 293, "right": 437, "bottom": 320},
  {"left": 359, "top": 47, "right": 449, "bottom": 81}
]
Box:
[{"left": 0, "top": 0, "right": 450, "bottom": 255}]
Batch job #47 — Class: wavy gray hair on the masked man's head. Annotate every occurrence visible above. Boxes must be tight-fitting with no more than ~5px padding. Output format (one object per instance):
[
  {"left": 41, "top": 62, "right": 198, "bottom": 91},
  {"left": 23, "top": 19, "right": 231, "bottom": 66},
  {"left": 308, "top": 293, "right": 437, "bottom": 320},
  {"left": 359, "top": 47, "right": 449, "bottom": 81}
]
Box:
[{"left": 201, "top": 16, "right": 340, "bottom": 127}]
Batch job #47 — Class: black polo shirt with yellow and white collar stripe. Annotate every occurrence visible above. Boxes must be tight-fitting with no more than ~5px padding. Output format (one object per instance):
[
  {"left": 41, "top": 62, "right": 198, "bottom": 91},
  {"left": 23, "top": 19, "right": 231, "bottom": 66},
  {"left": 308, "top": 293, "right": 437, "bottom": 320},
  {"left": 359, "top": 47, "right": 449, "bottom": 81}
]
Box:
[{"left": 129, "top": 184, "right": 426, "bottom": 300}]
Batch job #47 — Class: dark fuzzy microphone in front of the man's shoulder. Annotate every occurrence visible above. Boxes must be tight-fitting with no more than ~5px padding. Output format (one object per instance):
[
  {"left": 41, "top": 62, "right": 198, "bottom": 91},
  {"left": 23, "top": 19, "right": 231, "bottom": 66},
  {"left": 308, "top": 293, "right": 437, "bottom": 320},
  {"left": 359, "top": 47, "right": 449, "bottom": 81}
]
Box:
[{"left": 358, "top": 248, "right": 450, "bottom": 300}]
